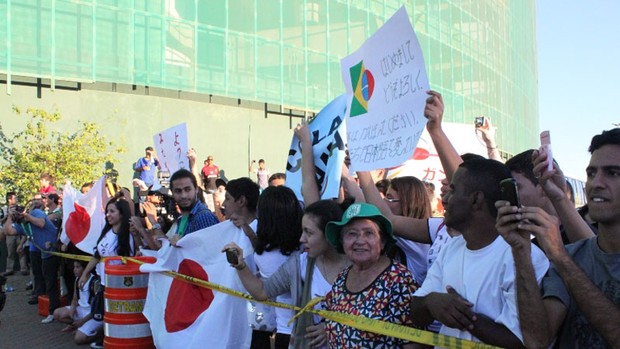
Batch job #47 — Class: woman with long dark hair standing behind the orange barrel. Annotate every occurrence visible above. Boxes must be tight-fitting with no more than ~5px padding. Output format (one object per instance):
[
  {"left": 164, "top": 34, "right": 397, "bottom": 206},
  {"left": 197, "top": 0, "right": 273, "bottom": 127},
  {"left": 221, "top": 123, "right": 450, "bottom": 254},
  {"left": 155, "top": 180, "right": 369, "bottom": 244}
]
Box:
[{"left": 78, "top": 197, "right": 135, "bottom": 288}]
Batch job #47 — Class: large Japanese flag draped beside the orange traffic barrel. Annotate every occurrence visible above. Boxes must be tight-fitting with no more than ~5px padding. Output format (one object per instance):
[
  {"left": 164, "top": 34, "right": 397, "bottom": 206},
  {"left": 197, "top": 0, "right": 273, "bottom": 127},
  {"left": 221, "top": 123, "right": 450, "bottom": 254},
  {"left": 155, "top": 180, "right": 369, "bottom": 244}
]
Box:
[{"left": 140, "top": 221, "right": 256, "bottom": 349}]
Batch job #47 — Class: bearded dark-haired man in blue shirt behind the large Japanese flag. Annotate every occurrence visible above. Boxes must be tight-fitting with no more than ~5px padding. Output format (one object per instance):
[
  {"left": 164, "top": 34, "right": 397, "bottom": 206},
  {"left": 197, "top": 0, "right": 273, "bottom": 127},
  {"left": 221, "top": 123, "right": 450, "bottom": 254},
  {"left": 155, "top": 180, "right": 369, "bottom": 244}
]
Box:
[{"left": 165, "top": 169, "right": 219, "bottom": 245}]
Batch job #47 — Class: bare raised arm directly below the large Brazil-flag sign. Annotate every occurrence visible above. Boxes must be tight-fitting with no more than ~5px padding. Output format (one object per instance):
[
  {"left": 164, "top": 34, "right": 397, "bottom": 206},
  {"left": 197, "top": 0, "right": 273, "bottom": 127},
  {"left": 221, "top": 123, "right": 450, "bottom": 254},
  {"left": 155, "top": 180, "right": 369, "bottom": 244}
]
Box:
[{"left": 357, "top": 172, "right": 432, "bottom": 244}]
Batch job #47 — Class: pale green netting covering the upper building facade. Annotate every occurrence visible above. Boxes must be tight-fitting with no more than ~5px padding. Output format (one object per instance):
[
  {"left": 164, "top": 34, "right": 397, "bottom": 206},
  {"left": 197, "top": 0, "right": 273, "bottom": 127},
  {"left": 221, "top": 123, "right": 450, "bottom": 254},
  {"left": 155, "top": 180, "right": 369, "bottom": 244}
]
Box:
[{"left": 0, "top": 0, "right": 538, "bottom": 153}]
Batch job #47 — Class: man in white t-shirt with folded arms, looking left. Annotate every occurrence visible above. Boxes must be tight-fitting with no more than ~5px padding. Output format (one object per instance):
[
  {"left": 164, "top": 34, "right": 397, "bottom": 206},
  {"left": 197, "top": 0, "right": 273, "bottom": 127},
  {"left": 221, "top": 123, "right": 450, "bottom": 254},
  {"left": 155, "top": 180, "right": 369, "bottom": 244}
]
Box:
[{"left": 412, "top": 159, "right": 549, "bottom": 348}]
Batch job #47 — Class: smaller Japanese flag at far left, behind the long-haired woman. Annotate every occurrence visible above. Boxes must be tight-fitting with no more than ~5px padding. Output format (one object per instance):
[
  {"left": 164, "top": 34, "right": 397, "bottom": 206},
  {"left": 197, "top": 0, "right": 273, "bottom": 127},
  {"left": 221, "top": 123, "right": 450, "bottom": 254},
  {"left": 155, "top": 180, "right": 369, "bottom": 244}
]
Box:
[{"left": 60, "top": 176, "right": 110, "bottom": 254}]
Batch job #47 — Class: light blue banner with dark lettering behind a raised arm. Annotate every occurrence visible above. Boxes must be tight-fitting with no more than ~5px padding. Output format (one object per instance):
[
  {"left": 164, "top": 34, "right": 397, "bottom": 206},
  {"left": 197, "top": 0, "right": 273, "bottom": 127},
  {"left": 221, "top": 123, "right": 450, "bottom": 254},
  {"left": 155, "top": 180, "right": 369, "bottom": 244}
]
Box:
[{"left": 286, "top": 94, "right": 347, "bottom": 201}]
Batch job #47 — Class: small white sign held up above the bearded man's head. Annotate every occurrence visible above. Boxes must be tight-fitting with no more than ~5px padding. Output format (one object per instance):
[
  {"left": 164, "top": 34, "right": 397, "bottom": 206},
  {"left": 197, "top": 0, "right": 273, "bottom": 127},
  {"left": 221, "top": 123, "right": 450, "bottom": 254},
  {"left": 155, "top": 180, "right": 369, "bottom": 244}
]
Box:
[{"left": 153, "top": 123, "right": 189, "bottom": 177}]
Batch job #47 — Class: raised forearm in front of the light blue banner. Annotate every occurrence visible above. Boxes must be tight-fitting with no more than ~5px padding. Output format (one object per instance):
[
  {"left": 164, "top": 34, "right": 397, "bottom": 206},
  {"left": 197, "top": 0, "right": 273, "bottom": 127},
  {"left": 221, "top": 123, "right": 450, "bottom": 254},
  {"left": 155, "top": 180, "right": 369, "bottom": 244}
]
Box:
[{"left": 295, "top": 121, "right": 321, "bottom": 207}]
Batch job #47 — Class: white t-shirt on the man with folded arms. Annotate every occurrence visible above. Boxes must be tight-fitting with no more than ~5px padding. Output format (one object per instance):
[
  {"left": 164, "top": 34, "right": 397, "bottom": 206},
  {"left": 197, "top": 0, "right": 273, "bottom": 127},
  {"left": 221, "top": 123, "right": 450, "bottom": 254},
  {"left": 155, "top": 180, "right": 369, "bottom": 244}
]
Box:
[{"left": 414, "top": 232, "right": 549, "bottom": 342}]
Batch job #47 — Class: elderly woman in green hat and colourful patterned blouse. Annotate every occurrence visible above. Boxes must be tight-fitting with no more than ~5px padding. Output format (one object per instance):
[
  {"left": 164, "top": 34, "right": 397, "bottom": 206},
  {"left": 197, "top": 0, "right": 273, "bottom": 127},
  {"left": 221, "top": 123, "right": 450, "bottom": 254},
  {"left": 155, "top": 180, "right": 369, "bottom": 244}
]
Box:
[{"left": 325, "top": 203, "right": 417, "bottom": 348}]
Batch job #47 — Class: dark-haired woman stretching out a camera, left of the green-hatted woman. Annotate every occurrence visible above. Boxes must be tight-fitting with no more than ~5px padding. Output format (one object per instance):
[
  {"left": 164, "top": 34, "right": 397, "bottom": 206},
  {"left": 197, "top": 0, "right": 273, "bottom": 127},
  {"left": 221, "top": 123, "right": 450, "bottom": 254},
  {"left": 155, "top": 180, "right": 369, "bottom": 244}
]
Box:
[{"left": 224, "top": 200, "right": 349, "bottom": 348}]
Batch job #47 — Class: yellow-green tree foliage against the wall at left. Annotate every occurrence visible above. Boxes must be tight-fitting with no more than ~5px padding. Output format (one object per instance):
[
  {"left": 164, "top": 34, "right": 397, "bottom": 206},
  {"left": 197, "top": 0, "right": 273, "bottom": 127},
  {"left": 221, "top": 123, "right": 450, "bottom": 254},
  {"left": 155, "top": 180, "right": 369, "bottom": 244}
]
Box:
[{"left": 0, "top": 106, "right": 124, "bottom": 198}]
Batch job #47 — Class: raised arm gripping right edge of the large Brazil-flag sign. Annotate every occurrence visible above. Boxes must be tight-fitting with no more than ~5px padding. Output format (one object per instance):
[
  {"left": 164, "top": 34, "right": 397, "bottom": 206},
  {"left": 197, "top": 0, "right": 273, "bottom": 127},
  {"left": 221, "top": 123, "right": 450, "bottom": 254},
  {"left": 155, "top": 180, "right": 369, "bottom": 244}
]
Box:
[{"left": 424, "top": 91, "right": 463, "bottom": 182}]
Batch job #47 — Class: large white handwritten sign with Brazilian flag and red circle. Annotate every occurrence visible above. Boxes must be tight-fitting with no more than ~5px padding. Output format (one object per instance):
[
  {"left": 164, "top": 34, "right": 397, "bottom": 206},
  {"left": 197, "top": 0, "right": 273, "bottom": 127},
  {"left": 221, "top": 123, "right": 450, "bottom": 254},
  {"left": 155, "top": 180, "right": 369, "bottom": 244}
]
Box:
[{"left": 341, "top": 7, "right": 429, "bottom": 172}]
